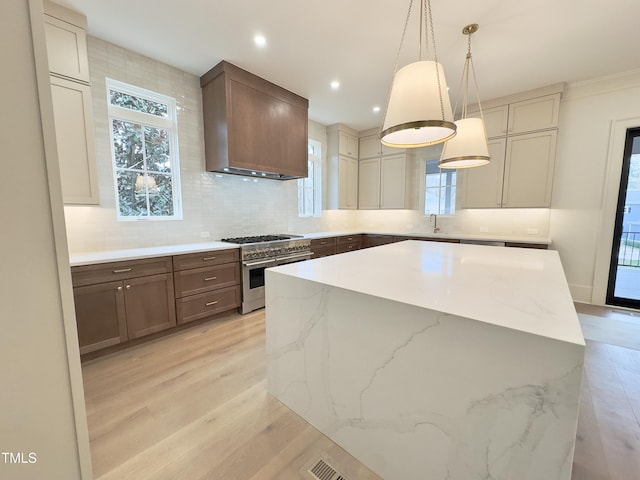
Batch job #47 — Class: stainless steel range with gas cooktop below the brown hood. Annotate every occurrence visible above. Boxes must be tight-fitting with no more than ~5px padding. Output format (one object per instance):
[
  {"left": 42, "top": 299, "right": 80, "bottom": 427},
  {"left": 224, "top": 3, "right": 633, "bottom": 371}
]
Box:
[{"left": 222, "top": 235, "right": 311, "bottom": 313}]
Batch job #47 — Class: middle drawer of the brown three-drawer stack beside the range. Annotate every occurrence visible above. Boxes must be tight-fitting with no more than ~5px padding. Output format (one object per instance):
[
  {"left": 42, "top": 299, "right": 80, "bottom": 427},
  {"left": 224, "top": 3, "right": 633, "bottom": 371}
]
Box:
[{"left": 173, "top": 263, "right": 240, "bottom": 298}]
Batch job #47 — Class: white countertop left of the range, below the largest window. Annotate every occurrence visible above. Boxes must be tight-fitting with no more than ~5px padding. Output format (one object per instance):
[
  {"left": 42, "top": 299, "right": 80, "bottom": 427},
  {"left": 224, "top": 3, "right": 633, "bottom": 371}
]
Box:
[{"left": 69, "top": 242, "right": 238, "bottom": 267}]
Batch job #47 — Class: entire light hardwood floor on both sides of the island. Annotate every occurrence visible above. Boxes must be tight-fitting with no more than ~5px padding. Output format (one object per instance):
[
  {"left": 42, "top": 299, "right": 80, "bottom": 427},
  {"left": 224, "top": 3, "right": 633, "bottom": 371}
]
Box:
[{"left": 83, "top": 306, "right": 640, "bottom": 480}]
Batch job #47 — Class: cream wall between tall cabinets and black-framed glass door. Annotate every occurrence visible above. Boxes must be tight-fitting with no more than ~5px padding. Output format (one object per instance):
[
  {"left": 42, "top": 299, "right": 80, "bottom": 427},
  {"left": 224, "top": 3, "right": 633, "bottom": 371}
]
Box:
[{"left": 550, "top": 70, "right": 640, "bottom": 303}]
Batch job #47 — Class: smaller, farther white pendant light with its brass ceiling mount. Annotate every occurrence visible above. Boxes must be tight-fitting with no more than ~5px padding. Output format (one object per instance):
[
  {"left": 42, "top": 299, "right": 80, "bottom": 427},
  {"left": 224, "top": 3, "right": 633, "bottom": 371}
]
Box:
[{"left": 439, "top": 23, "right": 491, "bottom": 168}]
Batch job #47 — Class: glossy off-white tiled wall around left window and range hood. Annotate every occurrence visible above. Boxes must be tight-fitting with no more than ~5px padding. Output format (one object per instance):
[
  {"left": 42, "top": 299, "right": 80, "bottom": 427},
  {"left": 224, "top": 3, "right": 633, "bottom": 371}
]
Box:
[{"left": 65, "top": 37, "right": 350, "bottom": 253}]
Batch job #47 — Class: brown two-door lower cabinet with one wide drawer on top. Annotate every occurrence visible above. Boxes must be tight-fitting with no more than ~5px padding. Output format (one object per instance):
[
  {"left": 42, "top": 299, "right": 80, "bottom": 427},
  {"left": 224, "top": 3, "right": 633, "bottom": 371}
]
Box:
[{"left": 71, "top": 257, "right": 176, "bottom": 354}]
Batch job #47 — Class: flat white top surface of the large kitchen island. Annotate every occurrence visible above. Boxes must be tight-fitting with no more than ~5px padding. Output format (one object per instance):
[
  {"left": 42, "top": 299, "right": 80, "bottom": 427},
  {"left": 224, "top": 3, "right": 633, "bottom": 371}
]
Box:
[{"left": 273, "top": 241, "right": 584, "bottom": 345}]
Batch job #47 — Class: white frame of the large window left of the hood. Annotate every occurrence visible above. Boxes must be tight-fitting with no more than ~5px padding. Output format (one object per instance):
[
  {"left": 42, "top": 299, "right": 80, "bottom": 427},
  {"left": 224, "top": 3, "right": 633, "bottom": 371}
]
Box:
[{"left": 105, "top": 78, "right": 183, "bottom": 222}]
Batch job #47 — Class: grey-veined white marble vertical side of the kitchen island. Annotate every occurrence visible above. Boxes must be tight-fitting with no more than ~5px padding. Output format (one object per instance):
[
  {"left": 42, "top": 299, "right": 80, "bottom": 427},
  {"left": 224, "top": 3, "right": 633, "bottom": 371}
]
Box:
[{"left": 266, "top": 247, "right": 584, "bottom": 480}]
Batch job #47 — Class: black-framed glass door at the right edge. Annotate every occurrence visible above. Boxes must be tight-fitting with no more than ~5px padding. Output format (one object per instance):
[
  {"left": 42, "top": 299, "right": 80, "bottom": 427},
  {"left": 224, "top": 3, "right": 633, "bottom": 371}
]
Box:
[{"left": 607, "top": 128, "right": 640, "bottom": 309}]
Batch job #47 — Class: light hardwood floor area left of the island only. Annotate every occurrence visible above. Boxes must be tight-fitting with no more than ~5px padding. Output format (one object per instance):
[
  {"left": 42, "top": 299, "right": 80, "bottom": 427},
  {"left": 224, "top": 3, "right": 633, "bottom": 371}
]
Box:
[{"left": 83, "top": 311, "right": 379, "bottom": 480}]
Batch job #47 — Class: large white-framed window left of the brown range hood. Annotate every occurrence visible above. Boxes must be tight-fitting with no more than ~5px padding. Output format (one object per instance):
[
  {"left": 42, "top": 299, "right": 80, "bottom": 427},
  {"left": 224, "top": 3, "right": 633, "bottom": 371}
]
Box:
[{"left": 107, "top": 79, "right": 182, "bottom": 220}]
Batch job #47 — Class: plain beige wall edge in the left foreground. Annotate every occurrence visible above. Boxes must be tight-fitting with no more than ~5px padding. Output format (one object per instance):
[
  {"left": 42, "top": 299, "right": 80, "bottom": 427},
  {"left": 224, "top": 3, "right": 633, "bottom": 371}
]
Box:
[{"left": 0, "top": 0, "right": 91, "bottom": 480}]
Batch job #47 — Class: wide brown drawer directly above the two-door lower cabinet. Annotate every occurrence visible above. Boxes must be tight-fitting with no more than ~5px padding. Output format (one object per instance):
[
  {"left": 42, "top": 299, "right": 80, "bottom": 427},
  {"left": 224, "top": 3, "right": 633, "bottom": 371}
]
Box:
[{"left": 71, "top": 257, "right": 172, "bottom": 287}]
